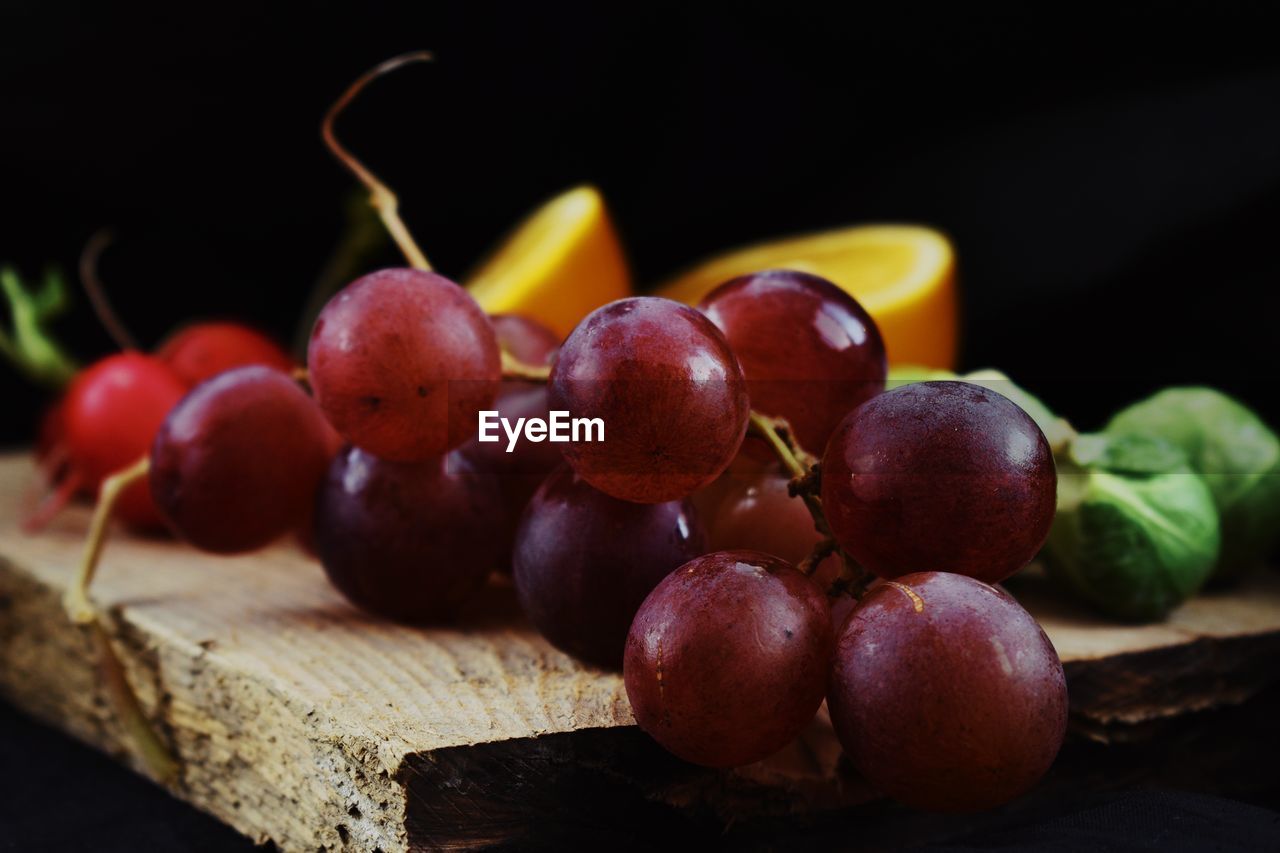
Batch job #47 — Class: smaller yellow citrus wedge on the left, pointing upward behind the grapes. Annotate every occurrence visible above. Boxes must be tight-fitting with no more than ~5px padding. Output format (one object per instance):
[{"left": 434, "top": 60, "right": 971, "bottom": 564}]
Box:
[{"left": 467, "top": 186, "right": 631, "bottom": 337}]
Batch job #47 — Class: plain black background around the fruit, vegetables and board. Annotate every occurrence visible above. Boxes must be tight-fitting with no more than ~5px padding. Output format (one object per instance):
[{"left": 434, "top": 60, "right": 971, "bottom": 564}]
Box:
[{"left": 0, "top": 3, "right": 1280, "bottom": 849}]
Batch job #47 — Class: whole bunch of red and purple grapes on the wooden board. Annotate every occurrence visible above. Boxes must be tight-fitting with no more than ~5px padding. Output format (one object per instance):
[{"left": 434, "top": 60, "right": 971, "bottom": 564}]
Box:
[{"left": 74, "top": 263, "right": 1066, "bottom": 809}]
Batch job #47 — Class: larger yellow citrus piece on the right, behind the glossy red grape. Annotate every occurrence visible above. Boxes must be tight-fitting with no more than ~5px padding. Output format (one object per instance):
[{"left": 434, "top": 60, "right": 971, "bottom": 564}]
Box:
[{"left": 657, "top": 225, "right": 957, "bottom": 369}]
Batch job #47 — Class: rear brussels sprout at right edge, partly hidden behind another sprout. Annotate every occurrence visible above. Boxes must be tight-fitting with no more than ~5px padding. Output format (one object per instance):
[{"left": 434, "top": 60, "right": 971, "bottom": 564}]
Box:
[{"left": 1105, "top": 388, "right": 1280, "bottom": 579}]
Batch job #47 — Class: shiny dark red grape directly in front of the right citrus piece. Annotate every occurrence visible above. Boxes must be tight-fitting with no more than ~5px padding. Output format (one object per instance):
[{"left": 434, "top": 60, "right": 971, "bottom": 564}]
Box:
[{"left": 700, "top": 269, "right": 888, "bottom": 455}]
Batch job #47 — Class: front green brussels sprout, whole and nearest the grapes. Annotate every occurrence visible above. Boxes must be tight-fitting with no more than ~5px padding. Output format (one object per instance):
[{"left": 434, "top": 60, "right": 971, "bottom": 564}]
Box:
[{"left": 1043, "top": 435, "right": 1220, "bottom": 621}]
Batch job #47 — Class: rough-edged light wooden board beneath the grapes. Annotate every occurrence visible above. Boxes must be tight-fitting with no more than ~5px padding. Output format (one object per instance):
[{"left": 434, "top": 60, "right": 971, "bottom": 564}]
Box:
[{"left": 0, "top": 456, "right": 1280, "bottom": 853}]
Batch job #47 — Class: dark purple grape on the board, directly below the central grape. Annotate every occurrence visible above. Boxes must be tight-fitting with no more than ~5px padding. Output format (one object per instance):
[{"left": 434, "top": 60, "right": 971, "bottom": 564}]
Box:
[{"left": 513, "top": 465, "right": 707, "bottom": 669}]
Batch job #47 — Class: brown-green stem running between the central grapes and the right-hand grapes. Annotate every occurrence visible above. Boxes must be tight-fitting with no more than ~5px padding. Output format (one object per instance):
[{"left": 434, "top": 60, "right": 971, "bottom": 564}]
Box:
[{"left": 748, "top": 410, "right": 874, "bottom": 598}]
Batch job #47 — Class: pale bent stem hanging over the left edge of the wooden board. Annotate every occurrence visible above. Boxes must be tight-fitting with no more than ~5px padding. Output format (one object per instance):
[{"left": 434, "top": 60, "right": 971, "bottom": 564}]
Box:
[{"left": 63, "top": 456, "right": 178, "bottom": 784}]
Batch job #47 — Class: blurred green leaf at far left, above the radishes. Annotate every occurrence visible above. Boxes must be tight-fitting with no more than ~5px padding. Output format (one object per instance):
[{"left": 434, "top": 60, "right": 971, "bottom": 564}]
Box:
[{"left": 0, "top": 266, "right": 78, "bottom": 388}]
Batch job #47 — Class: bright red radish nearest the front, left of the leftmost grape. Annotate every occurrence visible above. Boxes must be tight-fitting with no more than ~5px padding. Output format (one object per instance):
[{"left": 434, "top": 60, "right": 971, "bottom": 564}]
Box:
[{"left": 61, "top": 352, "right": 187, "bottom": 528}]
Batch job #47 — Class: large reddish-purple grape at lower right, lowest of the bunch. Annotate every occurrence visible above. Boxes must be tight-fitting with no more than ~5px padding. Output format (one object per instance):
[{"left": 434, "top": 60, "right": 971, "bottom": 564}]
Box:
[{"left": 827, "top": 571, "right": 1068, "bottom": 811}]
